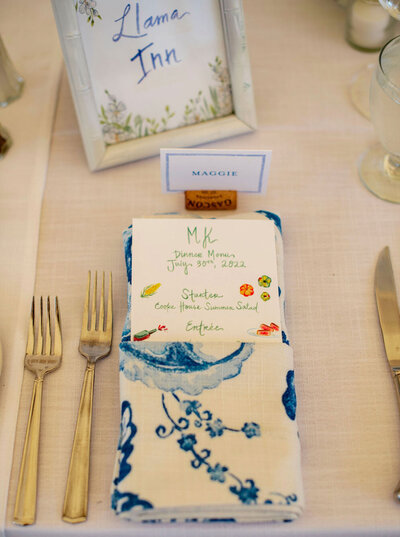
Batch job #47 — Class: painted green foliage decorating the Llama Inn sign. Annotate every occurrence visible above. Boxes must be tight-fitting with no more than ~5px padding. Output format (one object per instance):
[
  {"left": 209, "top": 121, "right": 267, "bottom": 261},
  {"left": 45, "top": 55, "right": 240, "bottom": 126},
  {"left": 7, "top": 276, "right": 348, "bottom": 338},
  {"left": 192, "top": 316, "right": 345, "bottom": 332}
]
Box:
[{"left": 98, "top": 57, "right": 232, "bottom": 145}]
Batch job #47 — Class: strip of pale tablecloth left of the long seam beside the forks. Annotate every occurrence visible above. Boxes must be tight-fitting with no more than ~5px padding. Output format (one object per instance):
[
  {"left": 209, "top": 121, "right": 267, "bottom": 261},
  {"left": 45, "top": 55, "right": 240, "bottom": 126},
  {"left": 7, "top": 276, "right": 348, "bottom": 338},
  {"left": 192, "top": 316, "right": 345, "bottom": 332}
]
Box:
[{"left": 0, "top": 1, "right": 62, "bottom": 535}]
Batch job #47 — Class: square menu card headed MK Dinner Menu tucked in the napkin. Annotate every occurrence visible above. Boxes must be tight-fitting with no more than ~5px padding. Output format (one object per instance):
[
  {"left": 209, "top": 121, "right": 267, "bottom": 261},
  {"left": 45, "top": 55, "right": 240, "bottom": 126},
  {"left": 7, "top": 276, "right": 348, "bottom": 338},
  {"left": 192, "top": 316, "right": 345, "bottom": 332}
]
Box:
[{"left": 131, "top": 218, "right": 282, "bottom": 342}]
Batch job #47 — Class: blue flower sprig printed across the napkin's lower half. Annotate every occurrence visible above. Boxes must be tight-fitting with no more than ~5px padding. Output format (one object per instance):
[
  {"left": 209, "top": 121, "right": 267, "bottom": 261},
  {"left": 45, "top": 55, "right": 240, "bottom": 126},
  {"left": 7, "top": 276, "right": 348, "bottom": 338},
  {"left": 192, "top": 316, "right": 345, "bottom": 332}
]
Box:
[{"left": 155, "top": 392, "right": 261, "bottom": 505}]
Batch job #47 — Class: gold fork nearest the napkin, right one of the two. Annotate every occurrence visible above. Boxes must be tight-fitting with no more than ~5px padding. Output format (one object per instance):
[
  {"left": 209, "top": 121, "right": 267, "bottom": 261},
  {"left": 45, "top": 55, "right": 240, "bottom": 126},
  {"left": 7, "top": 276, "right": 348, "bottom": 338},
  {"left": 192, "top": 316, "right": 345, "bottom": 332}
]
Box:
[{"left": 62, "top": 271, "right": 112, "bottom": 523}]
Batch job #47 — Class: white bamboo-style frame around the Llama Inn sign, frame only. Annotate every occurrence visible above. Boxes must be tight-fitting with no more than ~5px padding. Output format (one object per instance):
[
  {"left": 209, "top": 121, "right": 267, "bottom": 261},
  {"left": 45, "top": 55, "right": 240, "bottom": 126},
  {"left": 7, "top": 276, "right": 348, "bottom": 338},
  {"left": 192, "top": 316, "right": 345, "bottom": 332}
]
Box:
[{"left": 52, "top": 0, "right": 256, "bottom": 171}]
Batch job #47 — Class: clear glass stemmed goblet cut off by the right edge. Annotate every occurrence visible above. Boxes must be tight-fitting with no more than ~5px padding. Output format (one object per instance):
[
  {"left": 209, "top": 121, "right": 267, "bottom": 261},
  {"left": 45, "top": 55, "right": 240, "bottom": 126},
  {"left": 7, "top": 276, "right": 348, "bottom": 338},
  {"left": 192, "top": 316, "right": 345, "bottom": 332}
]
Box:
[{"left": 359, "top": 36, "right": 400, "bottom": 203}]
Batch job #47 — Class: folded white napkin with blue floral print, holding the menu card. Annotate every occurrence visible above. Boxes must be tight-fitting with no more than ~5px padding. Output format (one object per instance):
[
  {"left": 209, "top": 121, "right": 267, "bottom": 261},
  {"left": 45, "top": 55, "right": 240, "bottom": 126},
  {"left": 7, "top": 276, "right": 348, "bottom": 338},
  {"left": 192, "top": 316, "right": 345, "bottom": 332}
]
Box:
[{"left": 111, "top": 211, "right": 303, "bottom": 522}]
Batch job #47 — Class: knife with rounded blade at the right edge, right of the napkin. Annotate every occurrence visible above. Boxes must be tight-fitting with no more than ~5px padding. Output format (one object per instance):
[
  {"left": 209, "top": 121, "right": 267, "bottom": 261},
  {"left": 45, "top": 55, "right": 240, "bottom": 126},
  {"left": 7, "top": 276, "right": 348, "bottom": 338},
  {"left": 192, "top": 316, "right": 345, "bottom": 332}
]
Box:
[{"left": 375, "top": 246, "right": 400, "bottom": 502}]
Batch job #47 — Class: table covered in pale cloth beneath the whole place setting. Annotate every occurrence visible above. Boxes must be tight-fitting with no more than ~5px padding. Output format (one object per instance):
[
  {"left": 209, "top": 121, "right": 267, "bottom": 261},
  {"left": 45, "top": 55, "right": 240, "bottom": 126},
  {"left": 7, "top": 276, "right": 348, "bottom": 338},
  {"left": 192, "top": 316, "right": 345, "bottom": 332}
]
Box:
[{"left": 0, "top": 0, "right": 400, "bottom": 537}]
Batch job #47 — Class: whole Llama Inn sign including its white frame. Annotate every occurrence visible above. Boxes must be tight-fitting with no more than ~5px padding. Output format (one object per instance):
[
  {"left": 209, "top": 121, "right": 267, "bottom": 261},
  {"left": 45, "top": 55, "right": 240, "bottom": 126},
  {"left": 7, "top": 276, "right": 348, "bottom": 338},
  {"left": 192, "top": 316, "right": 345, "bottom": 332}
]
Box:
[{"left": 52, "top": 0, "right": 256, "bottom": 170}]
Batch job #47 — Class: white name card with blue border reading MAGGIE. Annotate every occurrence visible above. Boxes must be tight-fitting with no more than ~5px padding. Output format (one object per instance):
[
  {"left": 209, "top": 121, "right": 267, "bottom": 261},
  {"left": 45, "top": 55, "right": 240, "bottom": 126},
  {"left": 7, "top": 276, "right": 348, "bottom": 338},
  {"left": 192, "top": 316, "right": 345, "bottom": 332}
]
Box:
[{"left": 160, "top": 149, "right": 272, "bottom": 194}]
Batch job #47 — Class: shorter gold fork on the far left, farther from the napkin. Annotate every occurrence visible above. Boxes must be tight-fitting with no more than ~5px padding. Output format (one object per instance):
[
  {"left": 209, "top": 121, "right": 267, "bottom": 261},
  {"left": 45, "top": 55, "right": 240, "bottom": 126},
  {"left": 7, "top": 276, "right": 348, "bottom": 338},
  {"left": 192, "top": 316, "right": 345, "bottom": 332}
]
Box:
[{"left": 14, "top": 297, "right": 62, "bottom": 526}]
